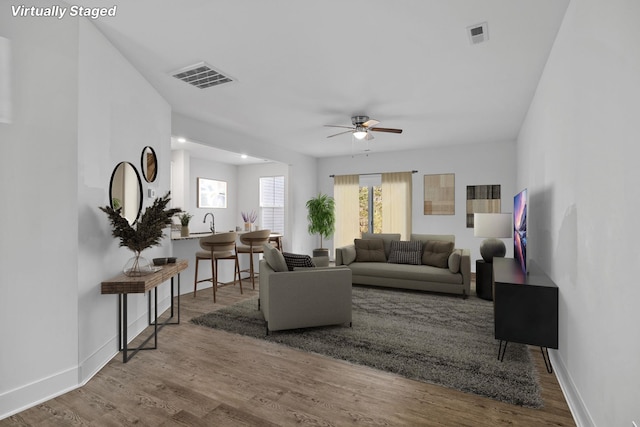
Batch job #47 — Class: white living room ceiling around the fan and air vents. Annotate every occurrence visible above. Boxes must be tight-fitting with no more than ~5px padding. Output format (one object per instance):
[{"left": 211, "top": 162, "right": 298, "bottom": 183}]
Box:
[{"left": 76, "top": 0, "right": 568, "bottom": 157}]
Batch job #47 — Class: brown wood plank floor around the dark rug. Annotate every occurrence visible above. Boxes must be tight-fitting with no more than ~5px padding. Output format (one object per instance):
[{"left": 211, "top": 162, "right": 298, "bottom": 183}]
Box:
[{"left": 0, "top": 284, "right": 575, "bottom": 427}]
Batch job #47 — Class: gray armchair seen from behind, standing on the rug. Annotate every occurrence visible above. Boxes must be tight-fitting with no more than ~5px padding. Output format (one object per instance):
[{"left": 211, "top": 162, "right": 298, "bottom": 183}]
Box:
[{"left": 259, "top": 259, "right": 351, "bottom": 334}]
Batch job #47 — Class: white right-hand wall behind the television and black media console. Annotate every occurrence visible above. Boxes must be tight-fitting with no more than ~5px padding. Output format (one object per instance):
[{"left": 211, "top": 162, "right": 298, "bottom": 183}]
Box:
[{"left": 518, "top": 0, "right": 640, "bottom": 427}]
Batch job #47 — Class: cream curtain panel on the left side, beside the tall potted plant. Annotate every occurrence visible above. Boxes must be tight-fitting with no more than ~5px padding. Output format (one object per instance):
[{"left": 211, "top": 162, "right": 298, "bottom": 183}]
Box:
[{"left": 333, "top": 175, "right": 360, "bottom": 248}]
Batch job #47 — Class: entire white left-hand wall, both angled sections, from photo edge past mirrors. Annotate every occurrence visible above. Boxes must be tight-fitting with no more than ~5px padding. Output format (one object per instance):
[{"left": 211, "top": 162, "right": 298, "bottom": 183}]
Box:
[{"left": 0, "top": 10, "right": 171, "bottom": 418}]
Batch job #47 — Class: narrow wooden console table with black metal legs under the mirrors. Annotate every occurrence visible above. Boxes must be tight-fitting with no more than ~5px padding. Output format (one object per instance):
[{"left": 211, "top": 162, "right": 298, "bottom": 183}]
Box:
[{"left": 102, "top": 259, "right": 188, "bottom": 363}]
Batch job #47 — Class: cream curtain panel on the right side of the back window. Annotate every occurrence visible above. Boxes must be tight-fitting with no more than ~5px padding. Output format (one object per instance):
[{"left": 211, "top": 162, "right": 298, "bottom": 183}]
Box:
[{"left": 382, "top": 172, "right": 413, "bottom": 240}]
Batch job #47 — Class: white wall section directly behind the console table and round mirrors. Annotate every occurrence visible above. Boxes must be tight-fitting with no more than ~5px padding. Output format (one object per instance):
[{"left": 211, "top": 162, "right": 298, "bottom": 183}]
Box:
[{"left": 77, "top": 16, "right": 171, "bottom": 381}]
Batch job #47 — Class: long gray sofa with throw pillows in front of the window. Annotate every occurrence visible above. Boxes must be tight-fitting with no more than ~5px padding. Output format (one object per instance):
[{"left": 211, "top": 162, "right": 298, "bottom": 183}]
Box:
[{"left": 336, "top": 233, "right": 471, "bottom": 297}]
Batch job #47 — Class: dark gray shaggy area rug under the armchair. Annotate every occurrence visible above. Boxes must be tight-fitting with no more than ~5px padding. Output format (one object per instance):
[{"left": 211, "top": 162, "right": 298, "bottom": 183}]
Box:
[{"left": 191, "top": 286, "right": 542, "bottom": 408}]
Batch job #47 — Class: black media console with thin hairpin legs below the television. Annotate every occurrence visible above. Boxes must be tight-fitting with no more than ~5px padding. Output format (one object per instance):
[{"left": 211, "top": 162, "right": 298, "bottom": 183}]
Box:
[{"left": 493, "top": 258, "right": 558, "bottom": 373}]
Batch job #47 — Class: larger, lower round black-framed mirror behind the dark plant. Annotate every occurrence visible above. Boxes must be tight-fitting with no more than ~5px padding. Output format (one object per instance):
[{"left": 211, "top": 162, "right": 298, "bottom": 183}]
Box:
[{"left": 109, "top": 162, "right": 142, "bottom": 224}]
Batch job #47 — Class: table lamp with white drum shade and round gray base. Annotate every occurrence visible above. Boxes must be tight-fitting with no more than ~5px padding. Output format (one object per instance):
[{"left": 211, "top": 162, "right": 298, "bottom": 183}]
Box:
[{"left": 473, "top": 213, "right": 513, "bottom": 263}]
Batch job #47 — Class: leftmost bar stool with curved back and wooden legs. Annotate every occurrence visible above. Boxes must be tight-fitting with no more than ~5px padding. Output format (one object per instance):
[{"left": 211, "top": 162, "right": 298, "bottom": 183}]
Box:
[{"left": 193, "top": 231, "right": 242, "bottom": 303}]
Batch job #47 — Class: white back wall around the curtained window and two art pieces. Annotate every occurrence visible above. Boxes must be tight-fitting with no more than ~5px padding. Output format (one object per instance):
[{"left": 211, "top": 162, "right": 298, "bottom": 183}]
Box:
[{"left": 318, "top": 142, "right": 519, "bottom": 271}]
